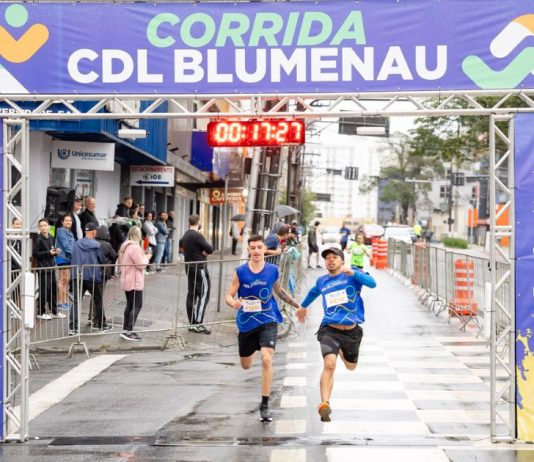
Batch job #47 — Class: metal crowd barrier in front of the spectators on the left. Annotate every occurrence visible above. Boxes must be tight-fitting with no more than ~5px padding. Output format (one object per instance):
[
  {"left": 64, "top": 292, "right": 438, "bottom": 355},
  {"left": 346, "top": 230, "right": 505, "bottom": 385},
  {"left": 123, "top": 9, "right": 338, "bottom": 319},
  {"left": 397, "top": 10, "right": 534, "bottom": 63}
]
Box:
[{"left": 24, "top": 247, "right": 302, "bottom": 354}]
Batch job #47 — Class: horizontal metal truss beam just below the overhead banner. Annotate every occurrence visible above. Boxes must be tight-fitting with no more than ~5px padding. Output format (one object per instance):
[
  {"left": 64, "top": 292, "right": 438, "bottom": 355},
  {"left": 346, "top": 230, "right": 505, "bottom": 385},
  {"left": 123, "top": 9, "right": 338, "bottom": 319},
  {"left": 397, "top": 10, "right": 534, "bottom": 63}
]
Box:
[{"left": 0, "top": 90, "right": 534, "bottom": 120}]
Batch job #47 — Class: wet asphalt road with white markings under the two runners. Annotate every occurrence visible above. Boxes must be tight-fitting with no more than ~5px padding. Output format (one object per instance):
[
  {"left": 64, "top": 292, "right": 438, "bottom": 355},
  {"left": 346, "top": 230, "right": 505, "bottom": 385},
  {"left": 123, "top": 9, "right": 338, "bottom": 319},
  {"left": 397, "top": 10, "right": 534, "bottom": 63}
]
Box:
[{"left": 0, "top": 270, "right": 534, "bottom": 462}]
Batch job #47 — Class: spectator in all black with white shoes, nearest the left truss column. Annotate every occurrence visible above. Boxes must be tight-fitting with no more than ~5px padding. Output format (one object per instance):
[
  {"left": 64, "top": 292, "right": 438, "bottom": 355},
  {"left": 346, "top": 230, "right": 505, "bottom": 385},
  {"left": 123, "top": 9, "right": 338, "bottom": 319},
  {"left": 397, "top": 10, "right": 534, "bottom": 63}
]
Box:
[{"left": 33, "top": 218, "right": 65, "bottom": 321}]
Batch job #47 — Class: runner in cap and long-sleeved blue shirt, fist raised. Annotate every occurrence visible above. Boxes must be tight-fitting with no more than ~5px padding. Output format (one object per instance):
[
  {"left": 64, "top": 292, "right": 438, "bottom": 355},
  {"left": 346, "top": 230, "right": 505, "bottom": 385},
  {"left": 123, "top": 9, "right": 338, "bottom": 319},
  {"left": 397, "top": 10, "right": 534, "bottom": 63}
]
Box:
[{"left": 296, "top": 247, "right": 376, "bottom": 422}]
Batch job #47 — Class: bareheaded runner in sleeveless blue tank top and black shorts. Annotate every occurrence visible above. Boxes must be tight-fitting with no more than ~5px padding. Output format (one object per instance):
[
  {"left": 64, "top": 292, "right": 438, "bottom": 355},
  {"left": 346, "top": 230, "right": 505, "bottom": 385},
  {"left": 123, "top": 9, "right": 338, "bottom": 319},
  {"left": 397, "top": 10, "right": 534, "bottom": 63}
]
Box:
[{"left": 226, "top": 235, "right": 300, "bottom": 422}]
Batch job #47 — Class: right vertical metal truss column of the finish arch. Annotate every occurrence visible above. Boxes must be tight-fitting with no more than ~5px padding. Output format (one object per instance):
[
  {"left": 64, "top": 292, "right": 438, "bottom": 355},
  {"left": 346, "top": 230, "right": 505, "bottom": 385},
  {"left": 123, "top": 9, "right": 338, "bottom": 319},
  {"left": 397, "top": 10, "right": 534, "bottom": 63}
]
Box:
[{"left": 489, "top": 115, "right": 516, "bottom": 442}]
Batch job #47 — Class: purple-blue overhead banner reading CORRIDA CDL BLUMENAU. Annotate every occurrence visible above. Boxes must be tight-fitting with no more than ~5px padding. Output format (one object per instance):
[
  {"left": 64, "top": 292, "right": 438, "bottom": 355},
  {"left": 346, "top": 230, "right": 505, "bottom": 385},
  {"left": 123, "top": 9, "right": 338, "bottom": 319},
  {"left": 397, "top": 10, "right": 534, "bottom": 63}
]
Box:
[{"left": 0, "top": 0, "right": 534, "bottom": 94}]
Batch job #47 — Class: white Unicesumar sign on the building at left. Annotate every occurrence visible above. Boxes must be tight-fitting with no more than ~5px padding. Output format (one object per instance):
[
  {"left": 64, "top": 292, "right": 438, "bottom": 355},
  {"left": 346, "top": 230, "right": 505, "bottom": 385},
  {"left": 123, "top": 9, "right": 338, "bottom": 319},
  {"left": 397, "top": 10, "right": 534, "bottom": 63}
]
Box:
[{"left": 52, "top": 140, "right": 115, "bottom": 171}]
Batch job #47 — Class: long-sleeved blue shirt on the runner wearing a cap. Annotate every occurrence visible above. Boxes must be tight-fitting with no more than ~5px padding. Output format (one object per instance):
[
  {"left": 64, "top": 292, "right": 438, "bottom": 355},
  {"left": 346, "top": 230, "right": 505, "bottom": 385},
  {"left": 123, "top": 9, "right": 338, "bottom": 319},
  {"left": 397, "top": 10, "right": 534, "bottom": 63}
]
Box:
[{"left": 302, "top": 269, "right": 376, "bottom": 326}]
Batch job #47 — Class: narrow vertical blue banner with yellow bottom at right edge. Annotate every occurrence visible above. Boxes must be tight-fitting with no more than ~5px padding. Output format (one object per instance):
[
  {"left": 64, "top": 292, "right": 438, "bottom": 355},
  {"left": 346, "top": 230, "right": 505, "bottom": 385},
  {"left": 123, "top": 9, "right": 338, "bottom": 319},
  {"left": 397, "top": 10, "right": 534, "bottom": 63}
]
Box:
[{"left": 514, "top": 114, "right": 534, "bottom": 441}]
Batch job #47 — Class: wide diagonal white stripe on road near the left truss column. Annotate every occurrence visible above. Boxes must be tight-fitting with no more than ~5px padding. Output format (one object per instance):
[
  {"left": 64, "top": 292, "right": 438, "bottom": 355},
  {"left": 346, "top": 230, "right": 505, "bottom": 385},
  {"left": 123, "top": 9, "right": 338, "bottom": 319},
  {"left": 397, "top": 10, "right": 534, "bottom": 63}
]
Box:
[{"left": 17, "top": 355, "right": 126, "bottom": 420}]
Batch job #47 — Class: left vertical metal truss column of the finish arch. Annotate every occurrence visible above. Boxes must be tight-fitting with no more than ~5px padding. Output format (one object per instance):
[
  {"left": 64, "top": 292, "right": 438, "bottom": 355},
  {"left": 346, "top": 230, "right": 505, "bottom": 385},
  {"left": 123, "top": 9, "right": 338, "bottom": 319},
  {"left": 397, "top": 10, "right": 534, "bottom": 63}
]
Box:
[{"left": 2, "top": 119, "right": 33, "bottom": 441}]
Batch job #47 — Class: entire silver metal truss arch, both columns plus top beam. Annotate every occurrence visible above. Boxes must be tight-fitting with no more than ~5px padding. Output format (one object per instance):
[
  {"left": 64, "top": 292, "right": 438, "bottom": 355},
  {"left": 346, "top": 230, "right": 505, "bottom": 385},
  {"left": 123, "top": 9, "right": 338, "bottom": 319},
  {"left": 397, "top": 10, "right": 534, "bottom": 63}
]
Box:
[{"left": 0, "top": 90, "right": 534, "bottom": 441}]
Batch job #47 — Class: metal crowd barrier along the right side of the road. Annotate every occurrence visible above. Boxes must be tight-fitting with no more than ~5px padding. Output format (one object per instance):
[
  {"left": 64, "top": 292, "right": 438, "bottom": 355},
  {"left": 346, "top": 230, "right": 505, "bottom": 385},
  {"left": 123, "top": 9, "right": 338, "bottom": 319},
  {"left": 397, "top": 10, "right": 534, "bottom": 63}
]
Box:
[{"left": 388, "top": 239, "right": 510, "bottom": 336}]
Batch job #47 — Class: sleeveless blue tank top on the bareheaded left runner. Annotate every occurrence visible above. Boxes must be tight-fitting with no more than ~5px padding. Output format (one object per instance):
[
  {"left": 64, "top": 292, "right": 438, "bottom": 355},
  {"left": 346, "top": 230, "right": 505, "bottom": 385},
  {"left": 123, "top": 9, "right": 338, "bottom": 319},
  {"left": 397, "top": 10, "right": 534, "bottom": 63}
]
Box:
[{"left": 236, "top": 263, "right": 282, "bottom": 332}]
